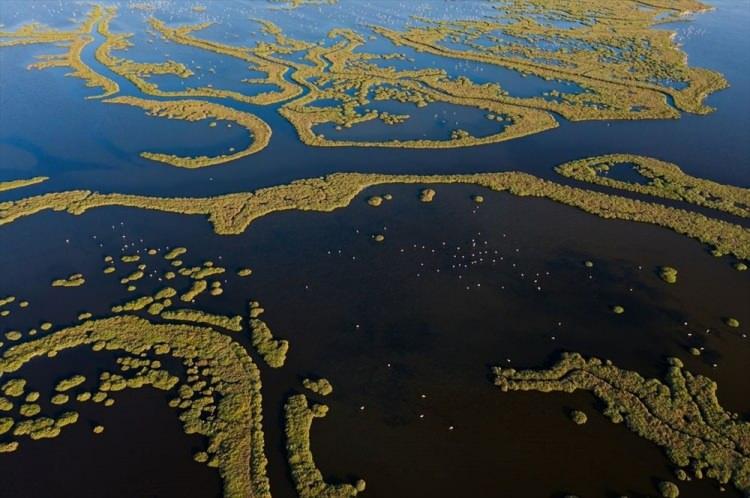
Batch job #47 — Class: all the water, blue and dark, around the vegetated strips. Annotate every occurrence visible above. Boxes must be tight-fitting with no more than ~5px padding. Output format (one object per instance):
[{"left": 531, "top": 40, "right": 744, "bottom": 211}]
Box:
[{"left": 0, "top": 0, "right": 750, "bottom": 498}]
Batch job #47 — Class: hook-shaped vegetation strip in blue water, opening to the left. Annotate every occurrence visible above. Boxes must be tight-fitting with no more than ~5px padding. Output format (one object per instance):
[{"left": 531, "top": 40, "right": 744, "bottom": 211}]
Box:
[{"left": 105, "top": 97, "right": 271, "bottom": 169}]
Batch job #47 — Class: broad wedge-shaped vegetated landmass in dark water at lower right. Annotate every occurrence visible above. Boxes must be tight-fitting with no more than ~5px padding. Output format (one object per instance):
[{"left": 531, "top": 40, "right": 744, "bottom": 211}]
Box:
[{"left": 493, "top": 353, "right": 750, "bottom": 494}]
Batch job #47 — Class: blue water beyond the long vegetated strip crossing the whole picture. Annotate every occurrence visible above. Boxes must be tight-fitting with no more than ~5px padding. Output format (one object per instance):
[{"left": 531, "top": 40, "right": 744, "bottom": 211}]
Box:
[{"left": 0, "top": 0, "right": 750, "bottom": 198}]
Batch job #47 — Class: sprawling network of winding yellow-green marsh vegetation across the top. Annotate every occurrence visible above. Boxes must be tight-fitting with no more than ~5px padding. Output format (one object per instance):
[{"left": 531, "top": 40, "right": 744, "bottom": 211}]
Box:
[{"left": 0, "top": 0, "right": 727, "bottom": 160}]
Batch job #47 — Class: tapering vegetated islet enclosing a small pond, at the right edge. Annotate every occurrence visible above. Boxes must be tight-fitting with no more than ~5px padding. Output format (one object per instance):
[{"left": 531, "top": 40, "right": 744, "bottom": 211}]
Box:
[{"left": 555, "top": 154, "right": 750, "bottom": 218}]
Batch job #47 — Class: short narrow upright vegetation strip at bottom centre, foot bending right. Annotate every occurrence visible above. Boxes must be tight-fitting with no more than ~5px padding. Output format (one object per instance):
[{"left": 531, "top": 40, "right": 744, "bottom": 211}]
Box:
[{"left": 284, "top": 394, "right": 365, "bottom": 498}]
